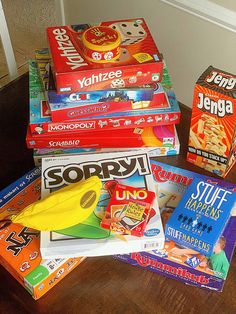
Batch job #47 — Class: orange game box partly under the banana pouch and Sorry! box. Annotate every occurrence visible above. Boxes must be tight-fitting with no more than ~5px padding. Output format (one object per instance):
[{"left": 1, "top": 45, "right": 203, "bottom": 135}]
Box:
[{"left": 0, "top": 168, "right": 84, "bottom": 299}]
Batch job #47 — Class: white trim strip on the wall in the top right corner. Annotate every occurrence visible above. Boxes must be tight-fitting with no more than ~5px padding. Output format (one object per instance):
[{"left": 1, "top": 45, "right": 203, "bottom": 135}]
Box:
[{"left": 161, "top": 0, "right": 236, "bottom": 33}]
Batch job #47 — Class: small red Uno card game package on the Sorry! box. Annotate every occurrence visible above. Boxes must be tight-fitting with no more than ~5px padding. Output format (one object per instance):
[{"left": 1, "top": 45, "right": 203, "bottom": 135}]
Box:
[{"left": 101, "top": 184, "right": 156, "bottom": 237}]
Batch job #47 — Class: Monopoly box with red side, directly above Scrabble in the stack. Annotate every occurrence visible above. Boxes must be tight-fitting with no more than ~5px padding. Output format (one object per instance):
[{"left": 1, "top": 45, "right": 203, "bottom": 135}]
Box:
[{"left": 29, "top": 60, "right": 180, "bottom": 135}]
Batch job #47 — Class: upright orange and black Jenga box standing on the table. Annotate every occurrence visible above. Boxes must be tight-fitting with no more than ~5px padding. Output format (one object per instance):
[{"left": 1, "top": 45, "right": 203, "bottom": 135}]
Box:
[{"left": 187, "top": 66, "right": 236, "bottom": 177}]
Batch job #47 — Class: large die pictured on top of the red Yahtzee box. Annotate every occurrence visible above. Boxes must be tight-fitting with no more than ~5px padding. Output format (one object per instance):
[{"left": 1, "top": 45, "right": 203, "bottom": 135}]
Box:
[{"left": 109, "top": 20, "right": 147, "bottom": 45}]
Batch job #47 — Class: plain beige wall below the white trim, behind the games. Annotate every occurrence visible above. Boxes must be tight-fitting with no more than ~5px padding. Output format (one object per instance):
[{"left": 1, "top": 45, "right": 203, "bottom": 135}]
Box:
[{"left": 64, "top": 0, "right": 236, "bottom": 107}]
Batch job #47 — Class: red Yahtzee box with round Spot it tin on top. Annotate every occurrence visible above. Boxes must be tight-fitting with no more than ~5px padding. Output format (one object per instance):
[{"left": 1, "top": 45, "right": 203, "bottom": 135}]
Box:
[{"left": 47, "top": 18, "right": 163, "bottom": 93}]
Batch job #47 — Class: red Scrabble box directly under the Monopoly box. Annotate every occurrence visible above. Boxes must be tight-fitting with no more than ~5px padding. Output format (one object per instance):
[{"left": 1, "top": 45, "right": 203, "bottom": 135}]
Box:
[{"left": 26, "top": 124, "right": 175, "bottom": 148}]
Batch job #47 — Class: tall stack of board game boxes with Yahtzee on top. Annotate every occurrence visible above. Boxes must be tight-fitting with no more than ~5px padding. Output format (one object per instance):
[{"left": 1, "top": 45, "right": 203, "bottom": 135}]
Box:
[{"left": 26, "top": 19, "right": 180, "bottom": 164}]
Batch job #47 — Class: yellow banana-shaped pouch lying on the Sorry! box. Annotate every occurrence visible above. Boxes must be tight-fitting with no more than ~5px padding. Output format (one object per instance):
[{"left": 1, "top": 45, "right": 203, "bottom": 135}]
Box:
[{"left": 11, "top": 176, "right": 102, "bottom": 231}]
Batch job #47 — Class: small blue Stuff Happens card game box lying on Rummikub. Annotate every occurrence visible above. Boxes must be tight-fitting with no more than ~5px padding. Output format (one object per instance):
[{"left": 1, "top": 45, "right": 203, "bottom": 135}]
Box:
[{"left": 165, "top": 179, "right": 236, "bottom": 256}]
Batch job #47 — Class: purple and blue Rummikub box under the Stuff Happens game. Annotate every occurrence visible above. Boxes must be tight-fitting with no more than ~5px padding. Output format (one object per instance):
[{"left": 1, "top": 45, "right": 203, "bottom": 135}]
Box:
[{"left": 115, "top": 159, "right": 236, "bottom": 291}]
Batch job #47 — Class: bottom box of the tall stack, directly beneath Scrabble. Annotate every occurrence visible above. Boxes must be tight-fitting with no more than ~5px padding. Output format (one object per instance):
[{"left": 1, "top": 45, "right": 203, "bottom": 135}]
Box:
[{"left": 33, "top": 129, "right": 180, "bottom": 166}]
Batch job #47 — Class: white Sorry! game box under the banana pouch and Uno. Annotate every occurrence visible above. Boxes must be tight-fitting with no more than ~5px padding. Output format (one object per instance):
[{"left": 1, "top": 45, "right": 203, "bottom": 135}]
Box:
[{"left": 41, "top": 151, "right": 164, "bottom": 258}]
